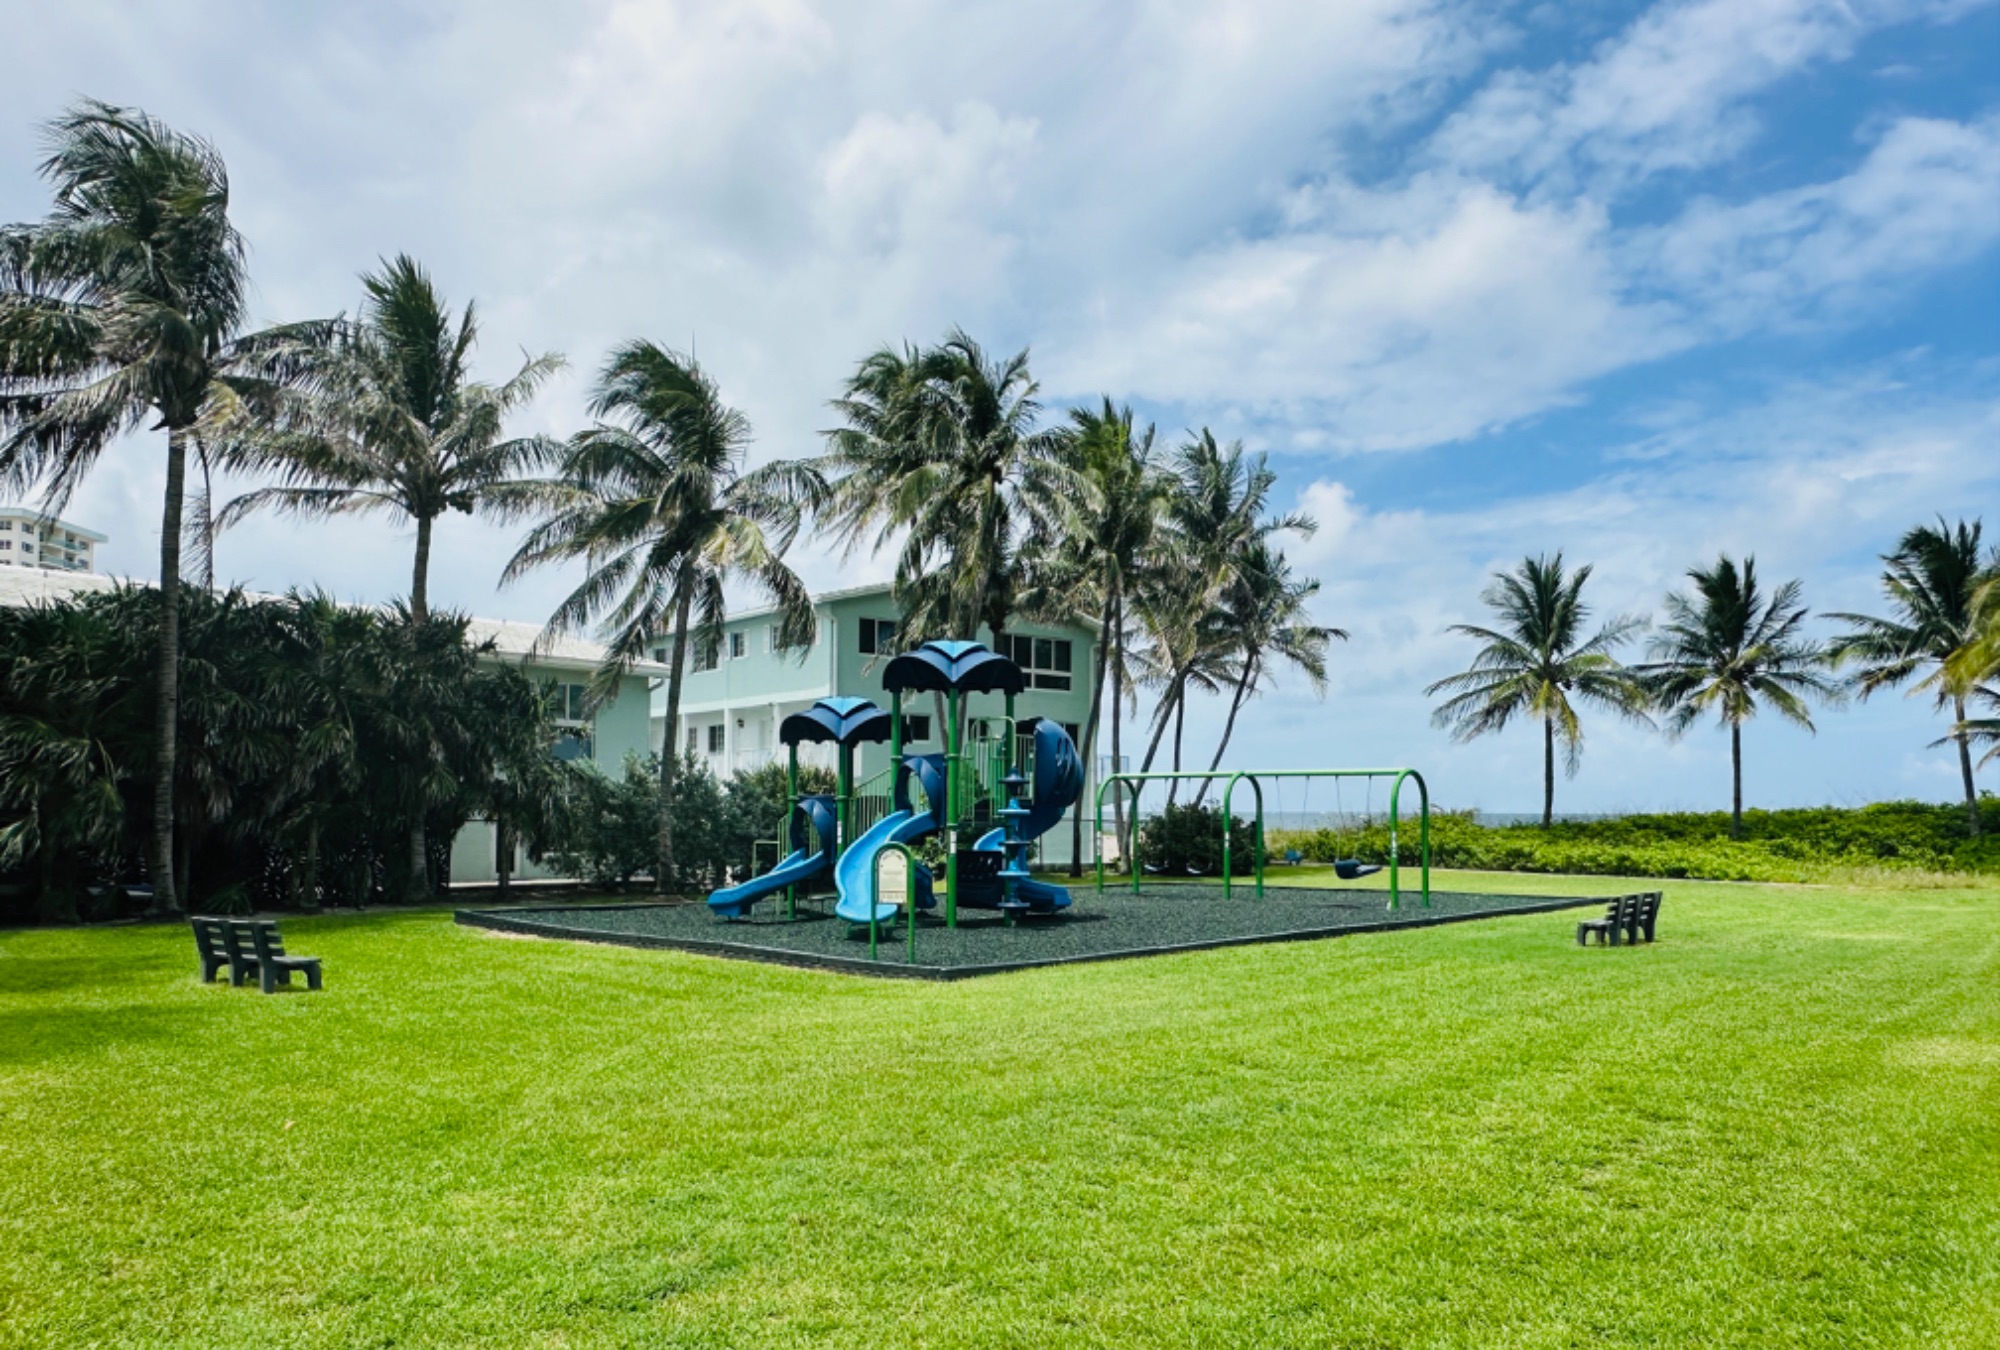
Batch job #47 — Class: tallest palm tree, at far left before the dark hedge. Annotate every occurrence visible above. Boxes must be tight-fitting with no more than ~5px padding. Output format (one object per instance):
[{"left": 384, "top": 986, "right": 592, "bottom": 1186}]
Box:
[{"left": 0, "top": 100, "right": 310, "bottom": 912}]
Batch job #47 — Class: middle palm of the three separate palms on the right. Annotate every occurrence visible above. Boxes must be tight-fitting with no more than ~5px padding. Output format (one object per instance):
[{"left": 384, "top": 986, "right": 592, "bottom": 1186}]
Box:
[{"left": 1636, "top": 554, "right": 1840, "bottom": 840}]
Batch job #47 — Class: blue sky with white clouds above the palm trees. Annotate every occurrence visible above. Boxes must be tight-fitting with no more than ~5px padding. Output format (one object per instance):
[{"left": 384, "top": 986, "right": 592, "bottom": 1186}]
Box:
[{"left": 0, "top": 0, "right": 2000, "bottom": 810}]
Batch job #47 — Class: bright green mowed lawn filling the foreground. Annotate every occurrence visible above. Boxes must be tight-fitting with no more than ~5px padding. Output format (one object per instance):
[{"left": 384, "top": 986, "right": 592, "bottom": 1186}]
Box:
[{"left": 0, "top": 874, "right": 2000, "bottom": 1348}]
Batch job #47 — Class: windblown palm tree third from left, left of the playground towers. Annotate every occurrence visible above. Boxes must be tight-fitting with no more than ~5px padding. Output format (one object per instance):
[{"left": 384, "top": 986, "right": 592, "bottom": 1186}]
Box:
[{"left": 502, "top": 340, "right": 824, "bottom": 892}]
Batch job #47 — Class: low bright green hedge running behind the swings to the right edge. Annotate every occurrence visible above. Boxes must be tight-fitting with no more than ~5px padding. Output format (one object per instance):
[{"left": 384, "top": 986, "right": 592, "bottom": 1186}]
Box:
[{"left": 1270, "top": 798, "right": 2000, "bottom": 882}]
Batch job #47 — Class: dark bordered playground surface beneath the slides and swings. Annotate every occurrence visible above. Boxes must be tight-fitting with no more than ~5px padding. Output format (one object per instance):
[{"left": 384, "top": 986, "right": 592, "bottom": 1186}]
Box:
[{"left": 456, "top": 882, "right": 1610, "bottom": 980}]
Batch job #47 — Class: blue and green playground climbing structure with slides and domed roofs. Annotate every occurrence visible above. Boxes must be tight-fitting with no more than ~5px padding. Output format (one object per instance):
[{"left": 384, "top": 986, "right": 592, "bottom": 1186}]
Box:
[{"left": 708, "top": 642, "right": 1084, "bottom": 936}]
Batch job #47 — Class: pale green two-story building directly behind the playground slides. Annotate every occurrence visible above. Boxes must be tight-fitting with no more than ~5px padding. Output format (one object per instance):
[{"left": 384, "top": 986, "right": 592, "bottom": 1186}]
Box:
[{"left": 652, "top": 586, "right": 1098, "bottom": 862}]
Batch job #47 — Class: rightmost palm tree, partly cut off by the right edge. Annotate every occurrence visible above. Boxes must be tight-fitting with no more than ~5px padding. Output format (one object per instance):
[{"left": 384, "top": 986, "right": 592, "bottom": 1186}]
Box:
[{"left": 1828, "top": 516, "right": 1996, "bottom": 836}]
